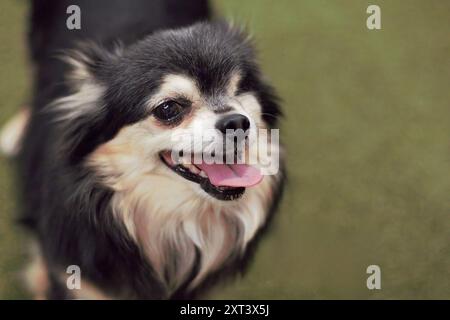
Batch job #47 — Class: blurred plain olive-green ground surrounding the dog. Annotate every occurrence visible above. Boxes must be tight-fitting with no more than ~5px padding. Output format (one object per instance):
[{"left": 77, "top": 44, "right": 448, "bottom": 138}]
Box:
[{"left": 0, "top": 0, "right": 450, "bottom": 299}]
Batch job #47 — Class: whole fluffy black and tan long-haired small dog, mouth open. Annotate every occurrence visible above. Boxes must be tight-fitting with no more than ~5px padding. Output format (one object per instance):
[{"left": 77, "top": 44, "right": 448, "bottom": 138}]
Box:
[{"left": 2, "top": 0, "right": 285, "bottom": 299}]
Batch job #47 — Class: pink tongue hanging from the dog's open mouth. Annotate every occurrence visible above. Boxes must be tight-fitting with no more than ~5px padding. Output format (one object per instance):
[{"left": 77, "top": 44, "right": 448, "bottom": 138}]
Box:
[{"left": 198, "top": 163, "right": 263, "bottom": 187}]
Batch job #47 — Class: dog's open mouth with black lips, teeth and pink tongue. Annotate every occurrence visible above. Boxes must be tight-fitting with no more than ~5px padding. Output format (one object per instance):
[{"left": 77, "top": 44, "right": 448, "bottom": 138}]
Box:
[{"left": 159, "top": 151, "right": 263, "bottom": 200}]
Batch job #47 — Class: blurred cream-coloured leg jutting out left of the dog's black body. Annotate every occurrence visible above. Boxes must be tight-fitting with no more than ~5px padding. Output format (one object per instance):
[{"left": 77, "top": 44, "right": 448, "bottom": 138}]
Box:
[{"left": 0, "top": 107, "right": 30, "bottom": 157}]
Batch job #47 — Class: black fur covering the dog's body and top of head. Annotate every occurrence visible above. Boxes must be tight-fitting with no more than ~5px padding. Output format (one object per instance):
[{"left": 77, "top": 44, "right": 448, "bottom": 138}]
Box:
[{"left": 20, "top": 0, "right": 281, "bottom": 299}]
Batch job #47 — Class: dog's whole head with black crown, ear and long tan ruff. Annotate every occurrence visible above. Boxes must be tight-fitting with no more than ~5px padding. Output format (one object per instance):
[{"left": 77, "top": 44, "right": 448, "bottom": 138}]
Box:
[{"left": 52, "top": 24, "right": 280, "bottom": 296}]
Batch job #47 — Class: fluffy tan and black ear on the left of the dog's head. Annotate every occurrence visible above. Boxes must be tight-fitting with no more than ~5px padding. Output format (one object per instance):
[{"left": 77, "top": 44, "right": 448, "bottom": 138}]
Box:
[{"left": 47, "top": 44, "right": 121, "bottom": 163}]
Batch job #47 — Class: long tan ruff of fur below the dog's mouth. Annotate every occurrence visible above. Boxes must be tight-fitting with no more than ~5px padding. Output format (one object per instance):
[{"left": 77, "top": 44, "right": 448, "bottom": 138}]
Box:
[{"left": 90, "top": 129, "right": 276, "bottom": 290}]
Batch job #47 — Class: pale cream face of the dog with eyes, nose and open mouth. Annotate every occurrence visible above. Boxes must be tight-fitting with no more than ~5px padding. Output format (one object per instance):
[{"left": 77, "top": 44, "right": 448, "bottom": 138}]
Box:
[{"left": 90, "top": 70, "right": 266, "bottom": 201}]
